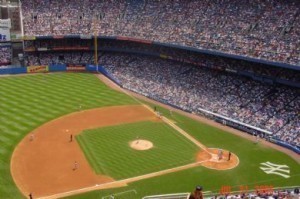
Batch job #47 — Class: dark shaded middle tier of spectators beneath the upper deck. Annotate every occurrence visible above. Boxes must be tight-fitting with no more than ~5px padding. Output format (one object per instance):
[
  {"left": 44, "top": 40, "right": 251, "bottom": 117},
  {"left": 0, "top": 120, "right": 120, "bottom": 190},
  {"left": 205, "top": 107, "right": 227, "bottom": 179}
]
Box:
[{"left": 25, "top": 39, "right": 300, "bottom": 82}]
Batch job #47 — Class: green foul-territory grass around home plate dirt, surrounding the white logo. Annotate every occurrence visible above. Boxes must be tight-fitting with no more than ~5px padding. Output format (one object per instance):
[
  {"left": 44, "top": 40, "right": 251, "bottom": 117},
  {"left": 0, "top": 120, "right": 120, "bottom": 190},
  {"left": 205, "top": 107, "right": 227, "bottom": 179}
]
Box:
[{"left": 68, "top": 98, "right": 300, "bottom": 199}]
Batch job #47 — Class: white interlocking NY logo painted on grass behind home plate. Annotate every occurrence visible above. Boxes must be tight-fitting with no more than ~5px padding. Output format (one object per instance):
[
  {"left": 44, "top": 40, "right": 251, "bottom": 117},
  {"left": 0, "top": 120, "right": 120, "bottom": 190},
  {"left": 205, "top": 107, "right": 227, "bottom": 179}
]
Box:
[{"left": 259, "top": 162, "right": 290, "bottom": 178}]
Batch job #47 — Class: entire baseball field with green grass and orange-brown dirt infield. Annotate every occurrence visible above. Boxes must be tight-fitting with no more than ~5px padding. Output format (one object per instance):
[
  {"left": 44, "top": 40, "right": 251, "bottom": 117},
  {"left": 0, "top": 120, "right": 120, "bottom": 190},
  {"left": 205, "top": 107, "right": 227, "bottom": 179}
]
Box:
[{"left": 0, "top": 73, "right": 300, "bottom": 199}]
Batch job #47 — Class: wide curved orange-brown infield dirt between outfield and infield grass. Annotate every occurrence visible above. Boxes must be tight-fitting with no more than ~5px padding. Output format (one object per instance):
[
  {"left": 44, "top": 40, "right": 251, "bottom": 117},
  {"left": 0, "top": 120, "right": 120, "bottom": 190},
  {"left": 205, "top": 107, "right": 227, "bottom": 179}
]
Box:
[{"left": 11, "top": 105, "right": 157, "bottom": 198}]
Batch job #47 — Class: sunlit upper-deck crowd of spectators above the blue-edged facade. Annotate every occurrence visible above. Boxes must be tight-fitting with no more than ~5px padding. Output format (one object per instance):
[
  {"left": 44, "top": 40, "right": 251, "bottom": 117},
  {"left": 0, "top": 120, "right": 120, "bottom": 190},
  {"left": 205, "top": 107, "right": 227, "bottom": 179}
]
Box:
[{"left": 22, "top": 0, "right": 300, "bottom": 65}]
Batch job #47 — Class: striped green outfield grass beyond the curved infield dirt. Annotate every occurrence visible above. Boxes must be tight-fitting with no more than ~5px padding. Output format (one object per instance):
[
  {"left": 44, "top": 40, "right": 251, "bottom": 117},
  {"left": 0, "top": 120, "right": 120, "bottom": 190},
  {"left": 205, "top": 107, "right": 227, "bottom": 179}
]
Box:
[{"left": 0, "top": 73, "right": 136, "bottom": 199}]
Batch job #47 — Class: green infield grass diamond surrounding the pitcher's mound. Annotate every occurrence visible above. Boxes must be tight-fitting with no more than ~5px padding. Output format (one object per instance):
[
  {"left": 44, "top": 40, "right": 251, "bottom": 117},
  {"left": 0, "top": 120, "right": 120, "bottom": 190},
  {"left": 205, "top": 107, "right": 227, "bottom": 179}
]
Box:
[{"left": 76, "top": 121, "right": 200, "bottom": 179}]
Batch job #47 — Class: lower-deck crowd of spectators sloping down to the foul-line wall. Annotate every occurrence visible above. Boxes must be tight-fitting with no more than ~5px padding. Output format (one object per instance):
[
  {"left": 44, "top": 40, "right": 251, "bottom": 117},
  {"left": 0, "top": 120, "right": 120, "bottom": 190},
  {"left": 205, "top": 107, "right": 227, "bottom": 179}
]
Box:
[{"left": 96, "top": 54, "right": 300, "bottom": 147}]
